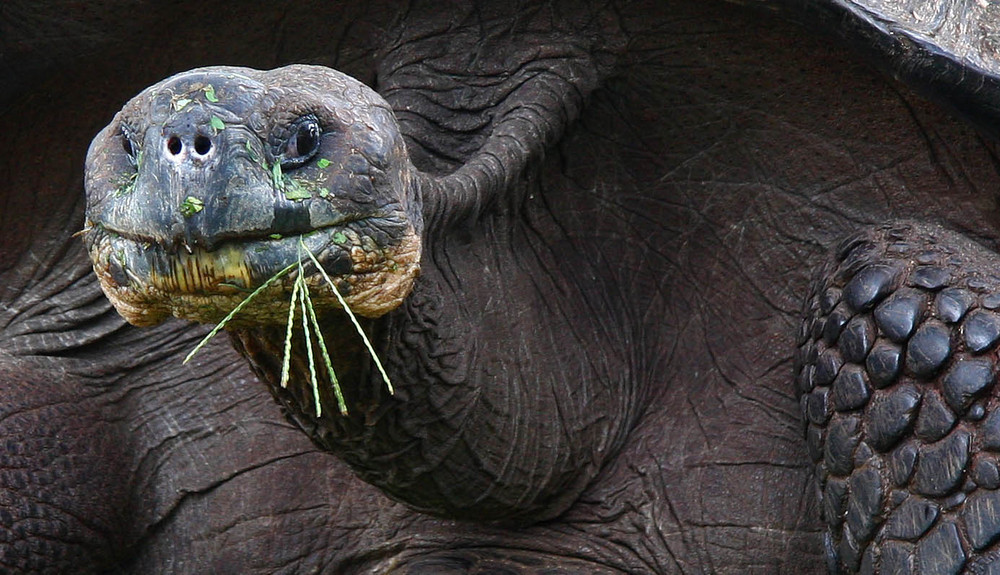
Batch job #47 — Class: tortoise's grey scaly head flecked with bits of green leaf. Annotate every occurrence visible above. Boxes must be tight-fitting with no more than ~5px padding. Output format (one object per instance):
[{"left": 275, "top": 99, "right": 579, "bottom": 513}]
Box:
[{"left": 85, "top": 66, "right": 422, "bottom": 325}]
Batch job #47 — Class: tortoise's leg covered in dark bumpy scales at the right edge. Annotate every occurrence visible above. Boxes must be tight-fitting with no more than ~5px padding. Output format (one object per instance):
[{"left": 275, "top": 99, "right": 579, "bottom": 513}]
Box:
[{"left": 796, "top": 223, "right": 1000, "bottom": 574}]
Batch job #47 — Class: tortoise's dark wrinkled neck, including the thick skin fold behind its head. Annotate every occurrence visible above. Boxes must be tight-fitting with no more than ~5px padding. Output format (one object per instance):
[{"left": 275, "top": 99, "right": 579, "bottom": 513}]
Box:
[{"left": 234, "top": 13, "right": 628, "bottom": 524}]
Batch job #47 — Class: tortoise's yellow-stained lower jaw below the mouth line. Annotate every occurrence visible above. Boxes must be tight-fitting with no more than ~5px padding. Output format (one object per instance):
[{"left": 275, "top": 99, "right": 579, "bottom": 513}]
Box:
[{"left": 87, "top": 218, "right": 420, "bottom": 327}]
